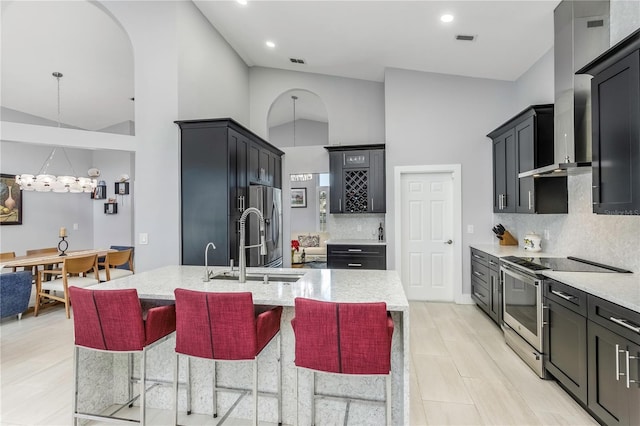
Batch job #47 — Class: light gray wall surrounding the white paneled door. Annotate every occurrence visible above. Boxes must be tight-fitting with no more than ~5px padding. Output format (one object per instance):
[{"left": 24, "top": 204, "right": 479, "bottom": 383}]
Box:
[{"left": 385, "top": 69, "right": 515, "bottom": 293}]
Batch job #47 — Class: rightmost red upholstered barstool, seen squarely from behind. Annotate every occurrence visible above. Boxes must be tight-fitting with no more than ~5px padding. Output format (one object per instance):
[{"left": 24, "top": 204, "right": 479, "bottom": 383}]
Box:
[{"left": 291, "top": 297, "right": 393, "bottom": 425}]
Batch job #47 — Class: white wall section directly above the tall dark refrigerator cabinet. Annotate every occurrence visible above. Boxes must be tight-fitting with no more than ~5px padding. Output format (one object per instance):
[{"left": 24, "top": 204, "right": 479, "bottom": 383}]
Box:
[{"left": 177, "top": 2, "right": 249, "bottom": 127}]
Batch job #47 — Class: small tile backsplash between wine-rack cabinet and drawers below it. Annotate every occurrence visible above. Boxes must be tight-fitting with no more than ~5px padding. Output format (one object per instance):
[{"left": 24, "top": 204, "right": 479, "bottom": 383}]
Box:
[{"left": 327, "top": 213, "right": 386, "bottom": 240}]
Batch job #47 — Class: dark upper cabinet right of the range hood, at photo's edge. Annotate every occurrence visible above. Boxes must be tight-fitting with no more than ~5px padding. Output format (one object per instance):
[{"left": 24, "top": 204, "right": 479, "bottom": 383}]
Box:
[{"left": 578, "top": 30, "right": 640, "bottom": 215}]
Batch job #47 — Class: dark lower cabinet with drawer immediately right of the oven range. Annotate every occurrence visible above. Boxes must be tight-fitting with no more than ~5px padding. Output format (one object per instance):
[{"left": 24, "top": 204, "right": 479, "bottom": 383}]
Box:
[{"left": 544, "top": 279, "right": 587, "bottom": 405}]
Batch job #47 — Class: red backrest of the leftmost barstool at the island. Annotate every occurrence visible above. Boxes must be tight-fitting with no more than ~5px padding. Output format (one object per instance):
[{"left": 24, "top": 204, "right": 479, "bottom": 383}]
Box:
[{"left": 69, "top": 287, "right": 146, "bottom": 351}]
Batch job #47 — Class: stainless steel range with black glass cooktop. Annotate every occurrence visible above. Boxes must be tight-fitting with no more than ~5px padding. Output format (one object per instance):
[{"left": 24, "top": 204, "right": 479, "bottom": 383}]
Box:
[{"left": 500, "top": 256, "right": 629, "bottom": 377}]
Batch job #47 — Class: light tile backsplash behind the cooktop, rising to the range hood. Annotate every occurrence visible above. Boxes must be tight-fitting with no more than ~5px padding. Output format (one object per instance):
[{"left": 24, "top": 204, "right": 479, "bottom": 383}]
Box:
[{"left": 494, "top": 173, "right": 640, "bottom": 273}]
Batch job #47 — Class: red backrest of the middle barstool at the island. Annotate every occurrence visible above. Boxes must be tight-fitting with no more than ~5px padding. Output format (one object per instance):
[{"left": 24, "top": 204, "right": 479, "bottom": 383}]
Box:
[{"left": 174, "top": 289, "right": 261, "bottom": 360}]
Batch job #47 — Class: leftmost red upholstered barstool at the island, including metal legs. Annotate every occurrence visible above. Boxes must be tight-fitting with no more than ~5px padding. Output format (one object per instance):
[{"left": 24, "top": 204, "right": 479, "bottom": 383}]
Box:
[{"left": 69, "top": 287, "right": 176, "bottom": 425}]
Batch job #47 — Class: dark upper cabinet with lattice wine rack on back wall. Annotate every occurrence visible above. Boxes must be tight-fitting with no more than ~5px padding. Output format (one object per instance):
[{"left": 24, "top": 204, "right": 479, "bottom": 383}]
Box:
[{"left": 326, "top": 145, "right": 386, "bottom": 213}]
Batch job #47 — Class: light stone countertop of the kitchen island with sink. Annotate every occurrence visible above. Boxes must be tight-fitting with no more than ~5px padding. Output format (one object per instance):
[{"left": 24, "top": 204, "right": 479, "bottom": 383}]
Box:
[{"left": 96, "top": 265, "right": 409, "bottom": 312}]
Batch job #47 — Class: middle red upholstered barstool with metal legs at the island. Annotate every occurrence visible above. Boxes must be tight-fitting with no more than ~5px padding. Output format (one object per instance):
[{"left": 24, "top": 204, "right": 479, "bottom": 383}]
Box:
[{"left": 174, "top": 289, "right": 282, "bottom": 425}]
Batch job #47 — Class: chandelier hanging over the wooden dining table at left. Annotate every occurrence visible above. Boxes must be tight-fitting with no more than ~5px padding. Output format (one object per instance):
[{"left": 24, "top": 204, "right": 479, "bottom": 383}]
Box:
[{"left": 16, "top": 72, "right": 97, "bottom": 193}]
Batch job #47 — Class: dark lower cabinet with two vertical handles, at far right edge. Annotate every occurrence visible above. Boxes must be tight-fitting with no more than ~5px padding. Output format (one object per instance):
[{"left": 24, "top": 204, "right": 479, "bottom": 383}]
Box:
[{"left": 587, "top": 296, "right": 640, "bottom": 425}]
